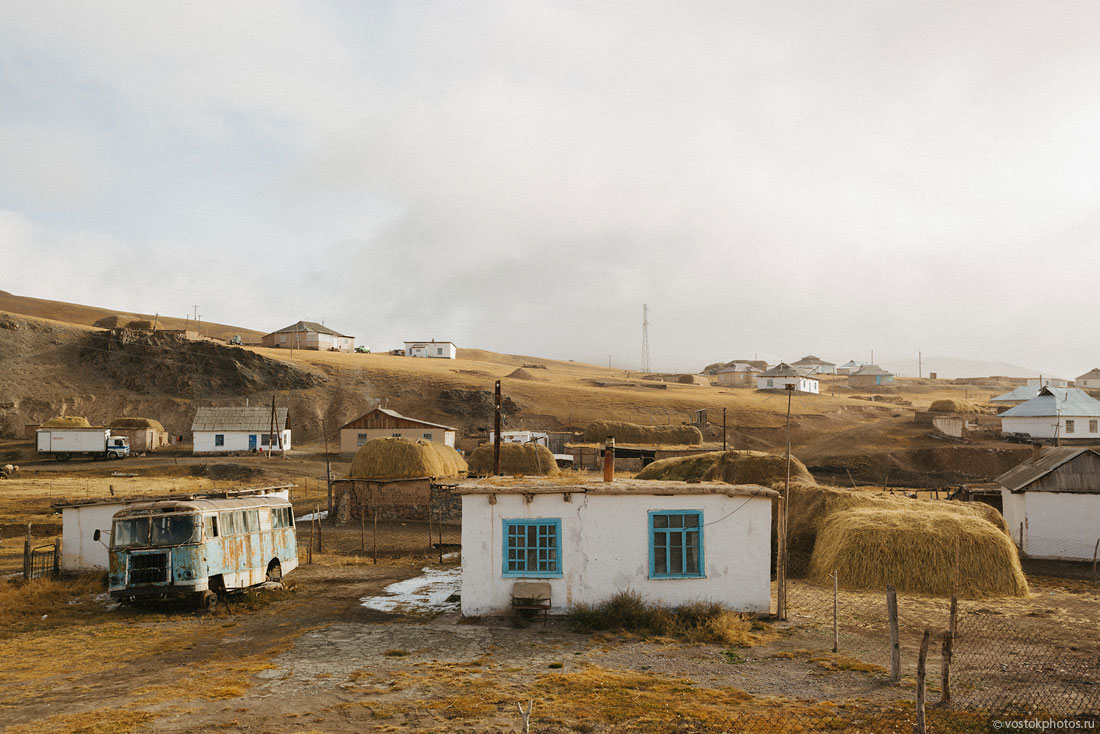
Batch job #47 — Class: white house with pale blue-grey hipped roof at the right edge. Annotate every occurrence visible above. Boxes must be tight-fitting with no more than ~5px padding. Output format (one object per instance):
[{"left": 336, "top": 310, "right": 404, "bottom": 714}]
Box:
[{"left": 1001, "top": 387, "right": 1100, "bottom": 442}]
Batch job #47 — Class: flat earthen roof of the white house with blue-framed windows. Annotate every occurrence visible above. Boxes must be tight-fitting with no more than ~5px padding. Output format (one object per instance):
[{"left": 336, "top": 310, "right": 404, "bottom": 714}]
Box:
[{"left": 454, "top": 478, "right": 779, "bottom": 499}]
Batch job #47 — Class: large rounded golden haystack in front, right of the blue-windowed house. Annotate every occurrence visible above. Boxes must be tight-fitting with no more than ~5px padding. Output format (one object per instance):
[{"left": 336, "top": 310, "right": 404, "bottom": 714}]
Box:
[{"left": 810, "top": 507, "right": 1027, "bottom": 599}]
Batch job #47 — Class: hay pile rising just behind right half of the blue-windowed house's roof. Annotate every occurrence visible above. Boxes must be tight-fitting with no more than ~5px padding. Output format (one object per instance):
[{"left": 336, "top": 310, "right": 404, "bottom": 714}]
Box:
[{"left": 636, "top": 450, "right": 814, "bottom": 487}]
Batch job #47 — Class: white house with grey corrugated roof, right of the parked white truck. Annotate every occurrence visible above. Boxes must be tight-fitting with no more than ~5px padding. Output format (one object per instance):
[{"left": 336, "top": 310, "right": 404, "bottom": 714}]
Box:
[{"left": 191, "top": 406, "right": 290, "bottom": 453}]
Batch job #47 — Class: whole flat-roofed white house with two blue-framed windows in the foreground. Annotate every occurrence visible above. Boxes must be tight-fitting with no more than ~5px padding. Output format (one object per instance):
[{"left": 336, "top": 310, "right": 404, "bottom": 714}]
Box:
[{"left": 457, "top": 480, "right": 778, "bottom": 616}]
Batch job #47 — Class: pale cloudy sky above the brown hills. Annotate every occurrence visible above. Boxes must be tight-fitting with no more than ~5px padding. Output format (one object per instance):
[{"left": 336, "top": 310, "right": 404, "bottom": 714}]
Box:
[{"left": 0, "top": 0, "right": 1100, "bottom": 377}]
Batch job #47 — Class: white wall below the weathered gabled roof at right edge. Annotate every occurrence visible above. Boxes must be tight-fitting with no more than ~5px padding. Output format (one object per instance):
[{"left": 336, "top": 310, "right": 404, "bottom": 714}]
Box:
[{"left": 1001, "top": 490, "right": 1100, "bottom": 561}]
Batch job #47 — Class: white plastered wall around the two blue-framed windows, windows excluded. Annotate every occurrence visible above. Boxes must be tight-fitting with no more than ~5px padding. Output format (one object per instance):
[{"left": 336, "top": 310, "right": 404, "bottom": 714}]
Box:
[{"left": 462, "top": 487, "right": 771, "bottom": 615}]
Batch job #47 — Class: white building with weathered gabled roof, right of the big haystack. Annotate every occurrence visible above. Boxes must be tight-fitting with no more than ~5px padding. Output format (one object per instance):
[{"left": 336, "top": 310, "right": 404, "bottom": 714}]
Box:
[{"left": 996, "top": 446, "right": 1100, "bottom": 561}]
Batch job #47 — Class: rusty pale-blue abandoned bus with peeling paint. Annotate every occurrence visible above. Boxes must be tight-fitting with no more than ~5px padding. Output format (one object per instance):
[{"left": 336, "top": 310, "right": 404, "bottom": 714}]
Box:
[{"left": 105, "top": 495, "right": 298, "bottom": 606}]
